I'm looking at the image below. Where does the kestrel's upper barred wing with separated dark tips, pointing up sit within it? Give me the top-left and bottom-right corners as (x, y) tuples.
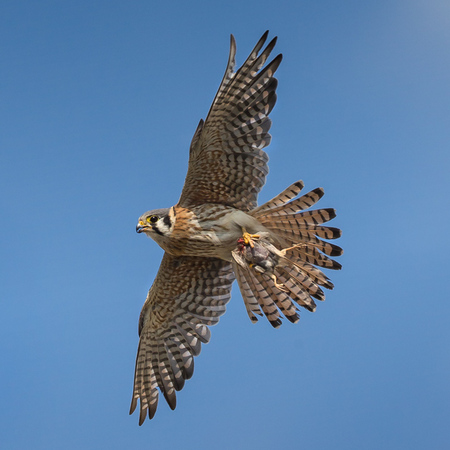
(178, 31), (282, 211)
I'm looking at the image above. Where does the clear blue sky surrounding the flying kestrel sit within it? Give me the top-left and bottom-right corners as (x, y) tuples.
(0, 0), (450, 450)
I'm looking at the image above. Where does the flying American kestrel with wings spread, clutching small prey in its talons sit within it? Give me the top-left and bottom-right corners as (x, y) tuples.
(130, 32), (342, 425)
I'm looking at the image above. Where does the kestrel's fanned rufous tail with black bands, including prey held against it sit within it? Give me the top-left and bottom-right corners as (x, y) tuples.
(233, 181), (342, 328)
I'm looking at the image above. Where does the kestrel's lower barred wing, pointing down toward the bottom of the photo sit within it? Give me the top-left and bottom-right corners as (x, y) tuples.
(130, 253), (234, 425)
